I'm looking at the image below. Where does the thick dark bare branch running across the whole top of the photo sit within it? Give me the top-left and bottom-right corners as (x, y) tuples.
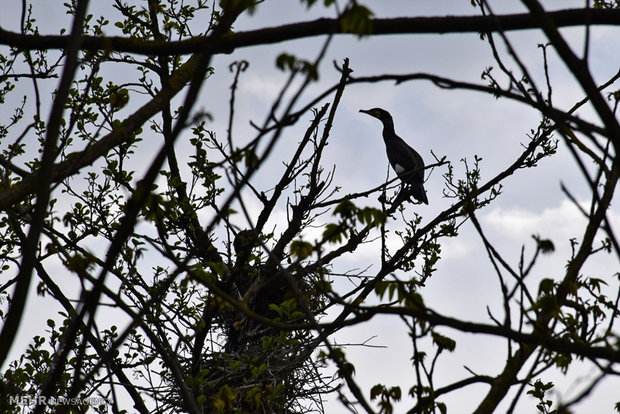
(0, 8), (620, 55)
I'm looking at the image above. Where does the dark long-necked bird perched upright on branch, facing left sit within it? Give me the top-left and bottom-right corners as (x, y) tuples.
(360, 108), (428, 204)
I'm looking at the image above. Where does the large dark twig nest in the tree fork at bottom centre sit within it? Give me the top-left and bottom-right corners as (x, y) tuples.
(159, 254), (333, 413)
